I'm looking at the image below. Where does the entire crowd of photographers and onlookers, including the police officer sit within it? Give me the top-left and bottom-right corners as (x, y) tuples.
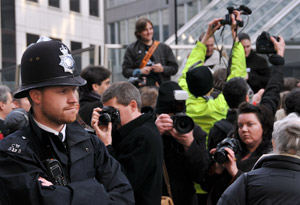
(0, 10), (300, 205)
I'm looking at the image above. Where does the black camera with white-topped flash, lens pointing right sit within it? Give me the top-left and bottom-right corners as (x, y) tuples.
(171, 90), (195, 134)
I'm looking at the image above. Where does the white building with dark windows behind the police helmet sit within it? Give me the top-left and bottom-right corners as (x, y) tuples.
(0, 0), (104, 89)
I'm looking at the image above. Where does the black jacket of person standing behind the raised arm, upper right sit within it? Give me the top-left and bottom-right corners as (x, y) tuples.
(246, 50), (271, 93)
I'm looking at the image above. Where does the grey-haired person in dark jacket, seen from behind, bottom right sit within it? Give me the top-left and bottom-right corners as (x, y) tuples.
(218, 113), (300, 205)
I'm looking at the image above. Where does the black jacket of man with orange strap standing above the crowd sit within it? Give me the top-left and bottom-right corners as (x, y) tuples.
(122, 40), (178, 83)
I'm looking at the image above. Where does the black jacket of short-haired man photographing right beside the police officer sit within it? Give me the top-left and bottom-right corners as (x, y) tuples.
(109, 113), (163, 205)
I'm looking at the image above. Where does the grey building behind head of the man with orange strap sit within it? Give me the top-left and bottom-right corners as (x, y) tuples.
(105, 0), (211, 45)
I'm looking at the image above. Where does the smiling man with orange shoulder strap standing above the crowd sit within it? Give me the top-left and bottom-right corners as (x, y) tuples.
(122, 17), (178, 86)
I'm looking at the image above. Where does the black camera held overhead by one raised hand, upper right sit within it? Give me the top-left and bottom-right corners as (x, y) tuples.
(256, 31), (279, 54)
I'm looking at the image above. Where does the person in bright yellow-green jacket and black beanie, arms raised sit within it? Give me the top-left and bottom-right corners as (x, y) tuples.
(178, 11), (247, 133)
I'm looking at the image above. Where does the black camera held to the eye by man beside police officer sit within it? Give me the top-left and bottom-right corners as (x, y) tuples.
(99, 106), (121, 125)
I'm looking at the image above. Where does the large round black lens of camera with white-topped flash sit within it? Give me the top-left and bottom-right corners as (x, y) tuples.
(173, 115), (194, 134)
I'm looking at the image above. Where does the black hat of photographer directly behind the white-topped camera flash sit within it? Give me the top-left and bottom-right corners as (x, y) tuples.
(155, 81), (182, 114)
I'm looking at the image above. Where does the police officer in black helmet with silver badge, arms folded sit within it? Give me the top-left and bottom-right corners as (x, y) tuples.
(0, 38), (134, 204)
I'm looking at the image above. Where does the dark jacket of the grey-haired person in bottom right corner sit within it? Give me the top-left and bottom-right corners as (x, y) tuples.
(218, 155), (300, 205)
